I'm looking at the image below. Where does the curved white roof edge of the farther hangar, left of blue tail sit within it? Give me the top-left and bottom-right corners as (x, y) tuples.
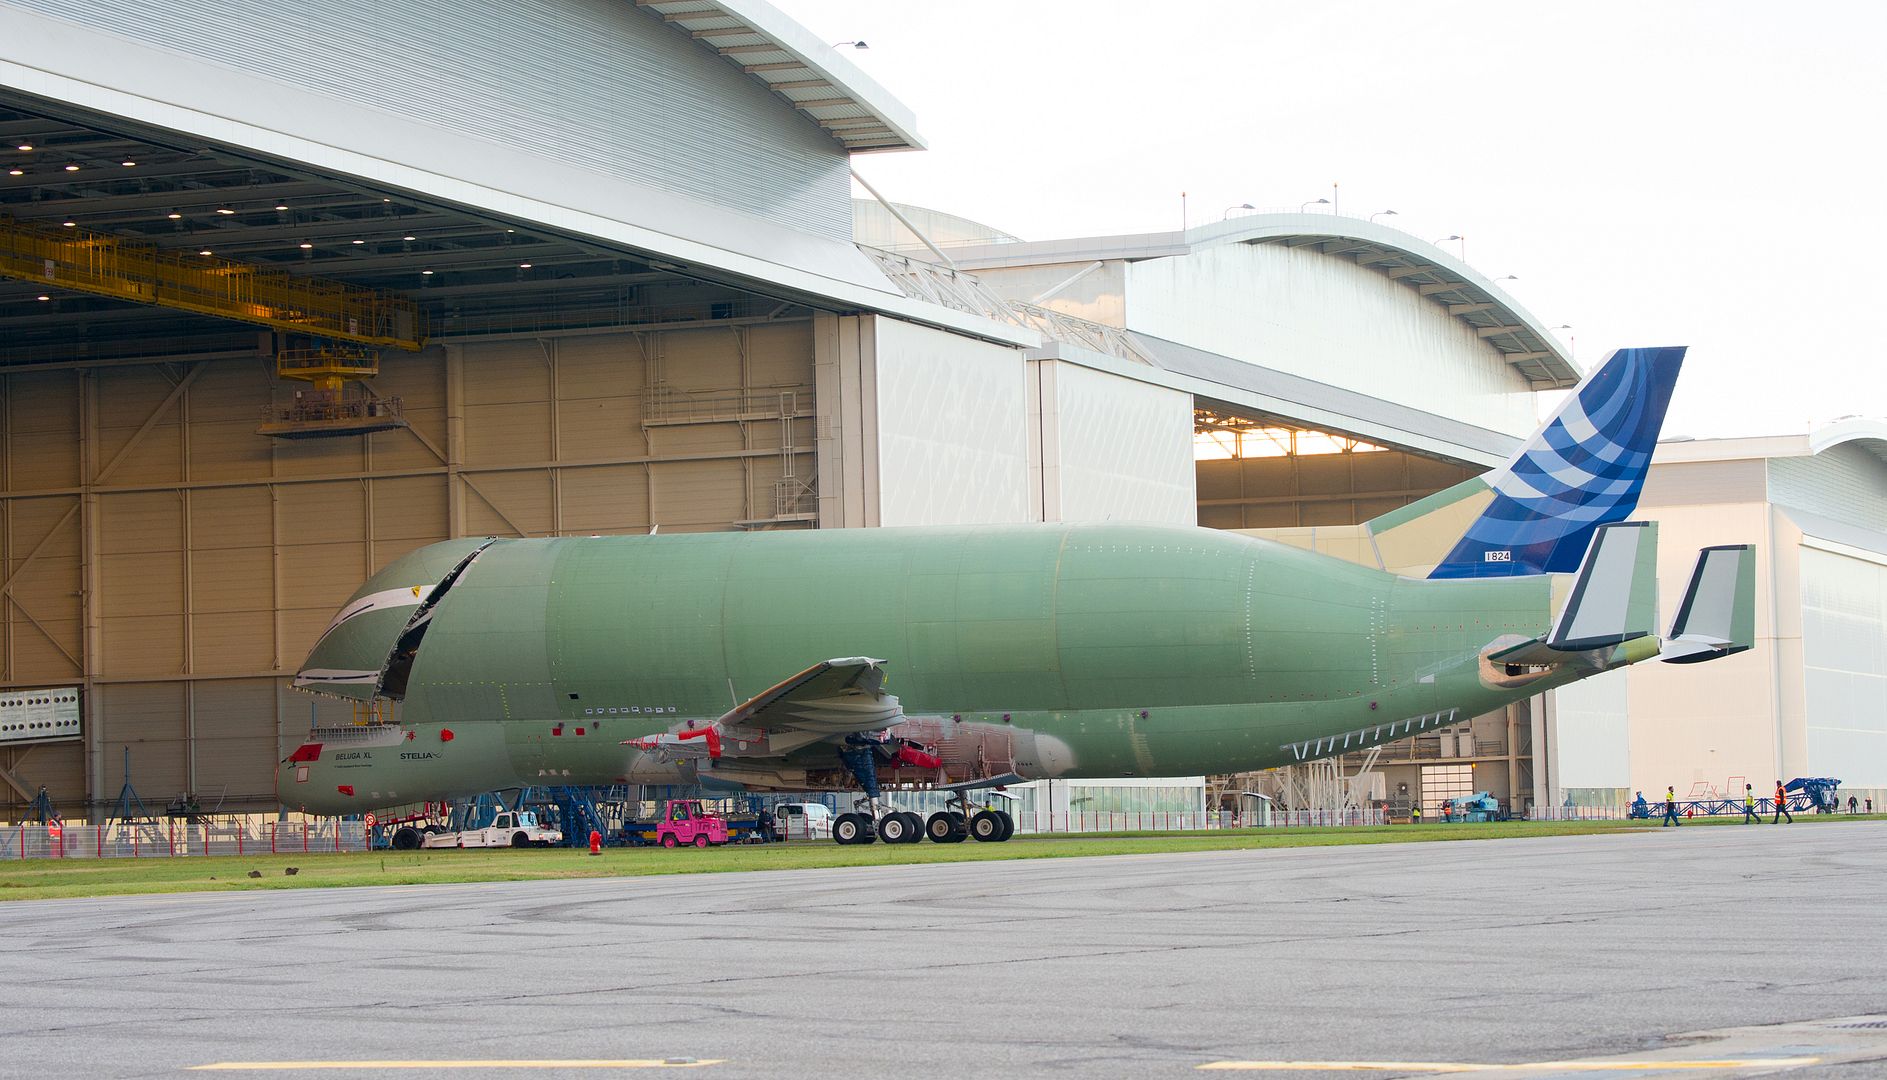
(951, 213), (1579, 389)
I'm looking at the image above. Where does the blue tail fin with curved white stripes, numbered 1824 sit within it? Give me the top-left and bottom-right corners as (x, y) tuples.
(1430, 346), (1683, 578)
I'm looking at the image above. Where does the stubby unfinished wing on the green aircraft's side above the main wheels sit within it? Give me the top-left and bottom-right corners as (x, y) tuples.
(626, 657), (904, 759)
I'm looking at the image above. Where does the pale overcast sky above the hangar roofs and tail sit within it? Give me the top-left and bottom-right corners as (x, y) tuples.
(774, 0), (1887, 436)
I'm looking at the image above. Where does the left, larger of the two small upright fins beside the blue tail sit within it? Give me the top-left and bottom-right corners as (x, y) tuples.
(1545, 521), (1657, 653)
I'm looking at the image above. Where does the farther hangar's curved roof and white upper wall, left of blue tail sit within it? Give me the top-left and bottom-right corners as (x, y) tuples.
(951, 213), (1579, 464)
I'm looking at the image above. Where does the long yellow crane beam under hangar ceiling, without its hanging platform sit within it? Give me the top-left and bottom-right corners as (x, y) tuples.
(0, 215), (426, 351)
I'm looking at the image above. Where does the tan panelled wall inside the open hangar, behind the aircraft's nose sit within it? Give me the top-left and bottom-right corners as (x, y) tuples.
(0, 321), (813, 819)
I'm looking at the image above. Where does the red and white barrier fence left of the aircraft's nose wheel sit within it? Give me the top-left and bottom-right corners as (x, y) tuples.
(0, 819), (366, 861)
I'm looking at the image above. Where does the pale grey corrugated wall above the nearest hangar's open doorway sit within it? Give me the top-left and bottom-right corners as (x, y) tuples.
(6, 0), (851, 240)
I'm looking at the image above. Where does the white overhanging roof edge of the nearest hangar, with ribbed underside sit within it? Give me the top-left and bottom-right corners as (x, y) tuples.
(636, 0), (925, 151)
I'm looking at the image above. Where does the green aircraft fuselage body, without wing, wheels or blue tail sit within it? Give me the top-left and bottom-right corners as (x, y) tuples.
(277, 525), (1622, 812)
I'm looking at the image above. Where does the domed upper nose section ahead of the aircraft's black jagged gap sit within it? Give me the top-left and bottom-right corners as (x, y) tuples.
(294, 536), (491, 700)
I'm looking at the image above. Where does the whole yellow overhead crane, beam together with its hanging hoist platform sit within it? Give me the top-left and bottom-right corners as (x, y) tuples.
(0, 215), (426, 438)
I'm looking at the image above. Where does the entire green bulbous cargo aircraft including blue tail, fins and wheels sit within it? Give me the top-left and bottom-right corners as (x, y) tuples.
(277, 347), (1755, 842)
